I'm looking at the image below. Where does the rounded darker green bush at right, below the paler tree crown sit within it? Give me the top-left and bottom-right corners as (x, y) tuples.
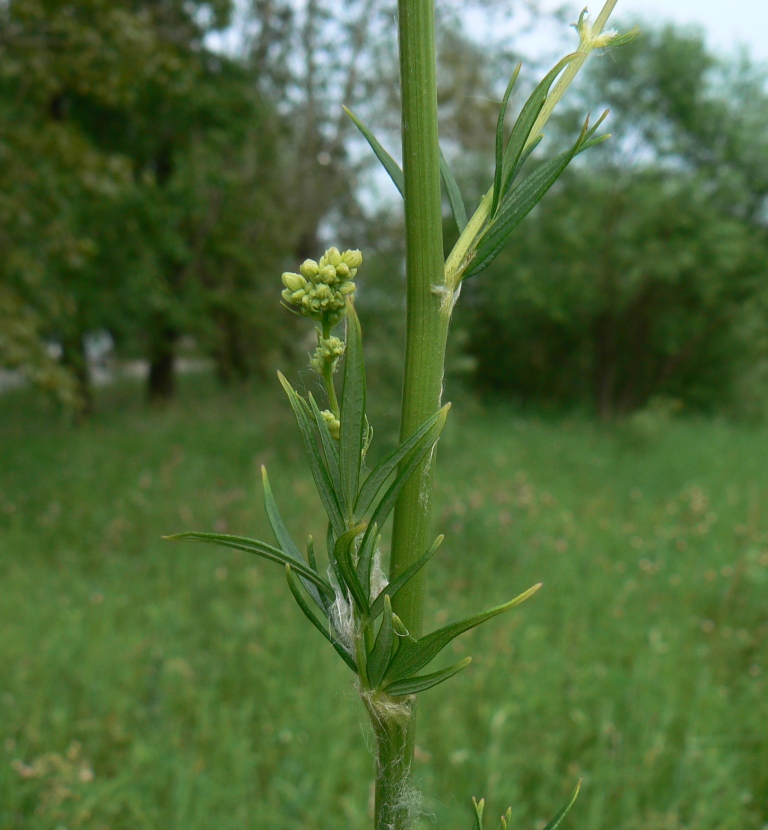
(468, 169), (768, 417)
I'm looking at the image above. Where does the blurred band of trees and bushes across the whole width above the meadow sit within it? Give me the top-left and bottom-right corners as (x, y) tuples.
(0, 8), (768, 417)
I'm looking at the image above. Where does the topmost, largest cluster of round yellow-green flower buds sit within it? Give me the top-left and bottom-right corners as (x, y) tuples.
(282, 248), (363, 326)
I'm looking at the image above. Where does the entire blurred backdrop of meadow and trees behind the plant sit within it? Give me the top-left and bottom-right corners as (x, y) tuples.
(0, 0), (768, 830)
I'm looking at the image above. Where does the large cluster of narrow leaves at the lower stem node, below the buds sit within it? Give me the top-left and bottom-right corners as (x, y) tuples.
(167, 301), (540, 698)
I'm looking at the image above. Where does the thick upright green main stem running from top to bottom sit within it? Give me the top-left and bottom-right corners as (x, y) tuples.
(373, 0), (450, 830)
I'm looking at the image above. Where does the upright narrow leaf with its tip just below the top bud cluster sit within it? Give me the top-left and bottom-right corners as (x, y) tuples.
(339, 300), (365, 520)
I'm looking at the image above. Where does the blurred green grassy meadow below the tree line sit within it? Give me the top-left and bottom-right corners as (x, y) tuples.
(0, 378), (768, 830)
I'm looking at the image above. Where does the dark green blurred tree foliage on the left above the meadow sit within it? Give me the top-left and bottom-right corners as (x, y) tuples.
(0, 0), (293, 407)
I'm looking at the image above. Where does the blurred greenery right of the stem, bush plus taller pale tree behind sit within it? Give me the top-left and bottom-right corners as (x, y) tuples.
(465, 28), (768, 417)
